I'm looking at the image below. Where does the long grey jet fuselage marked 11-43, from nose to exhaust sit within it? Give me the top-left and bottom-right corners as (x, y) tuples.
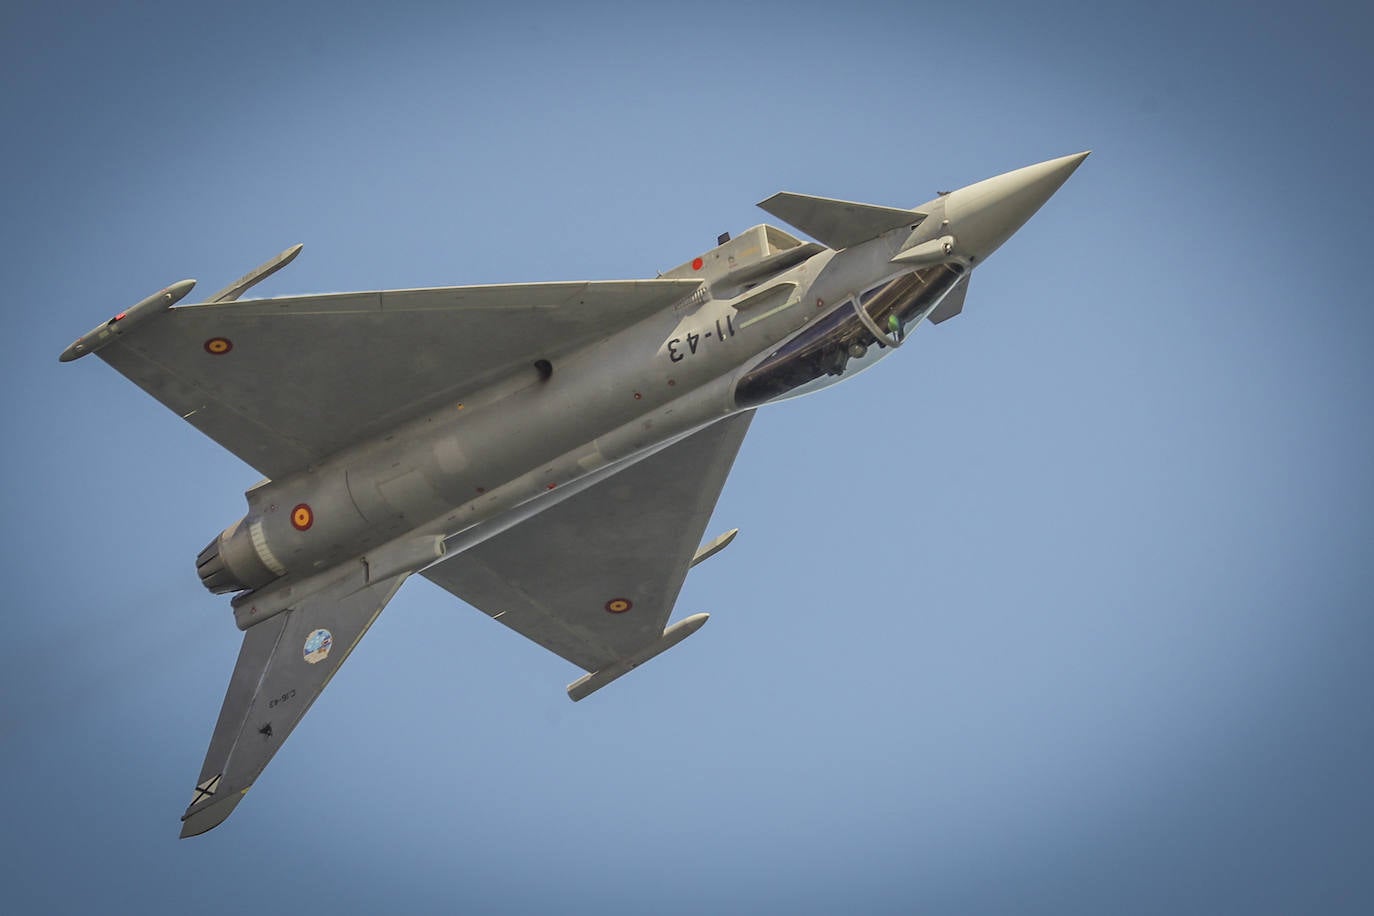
(198, 157), (1077, 628)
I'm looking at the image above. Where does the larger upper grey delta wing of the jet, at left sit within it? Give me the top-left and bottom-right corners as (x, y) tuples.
(96, 280), (701, 478)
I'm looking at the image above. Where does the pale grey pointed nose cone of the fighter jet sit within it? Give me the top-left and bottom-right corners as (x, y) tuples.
(945, 150), (1091, 262)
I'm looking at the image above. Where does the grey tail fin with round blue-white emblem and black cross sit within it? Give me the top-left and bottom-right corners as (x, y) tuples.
(181, 574), (407, 838)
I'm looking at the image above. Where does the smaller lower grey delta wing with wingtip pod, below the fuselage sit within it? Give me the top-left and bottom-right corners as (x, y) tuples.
(420, 411), (753, 699)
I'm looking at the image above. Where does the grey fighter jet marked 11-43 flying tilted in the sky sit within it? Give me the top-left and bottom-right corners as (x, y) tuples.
(60, 152), (1088, 836)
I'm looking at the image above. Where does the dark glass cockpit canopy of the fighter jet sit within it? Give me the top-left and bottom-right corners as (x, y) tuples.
(735, 264), (963, 408)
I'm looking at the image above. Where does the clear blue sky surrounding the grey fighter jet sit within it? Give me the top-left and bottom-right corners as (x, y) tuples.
(0, 1), (1374, 913)
